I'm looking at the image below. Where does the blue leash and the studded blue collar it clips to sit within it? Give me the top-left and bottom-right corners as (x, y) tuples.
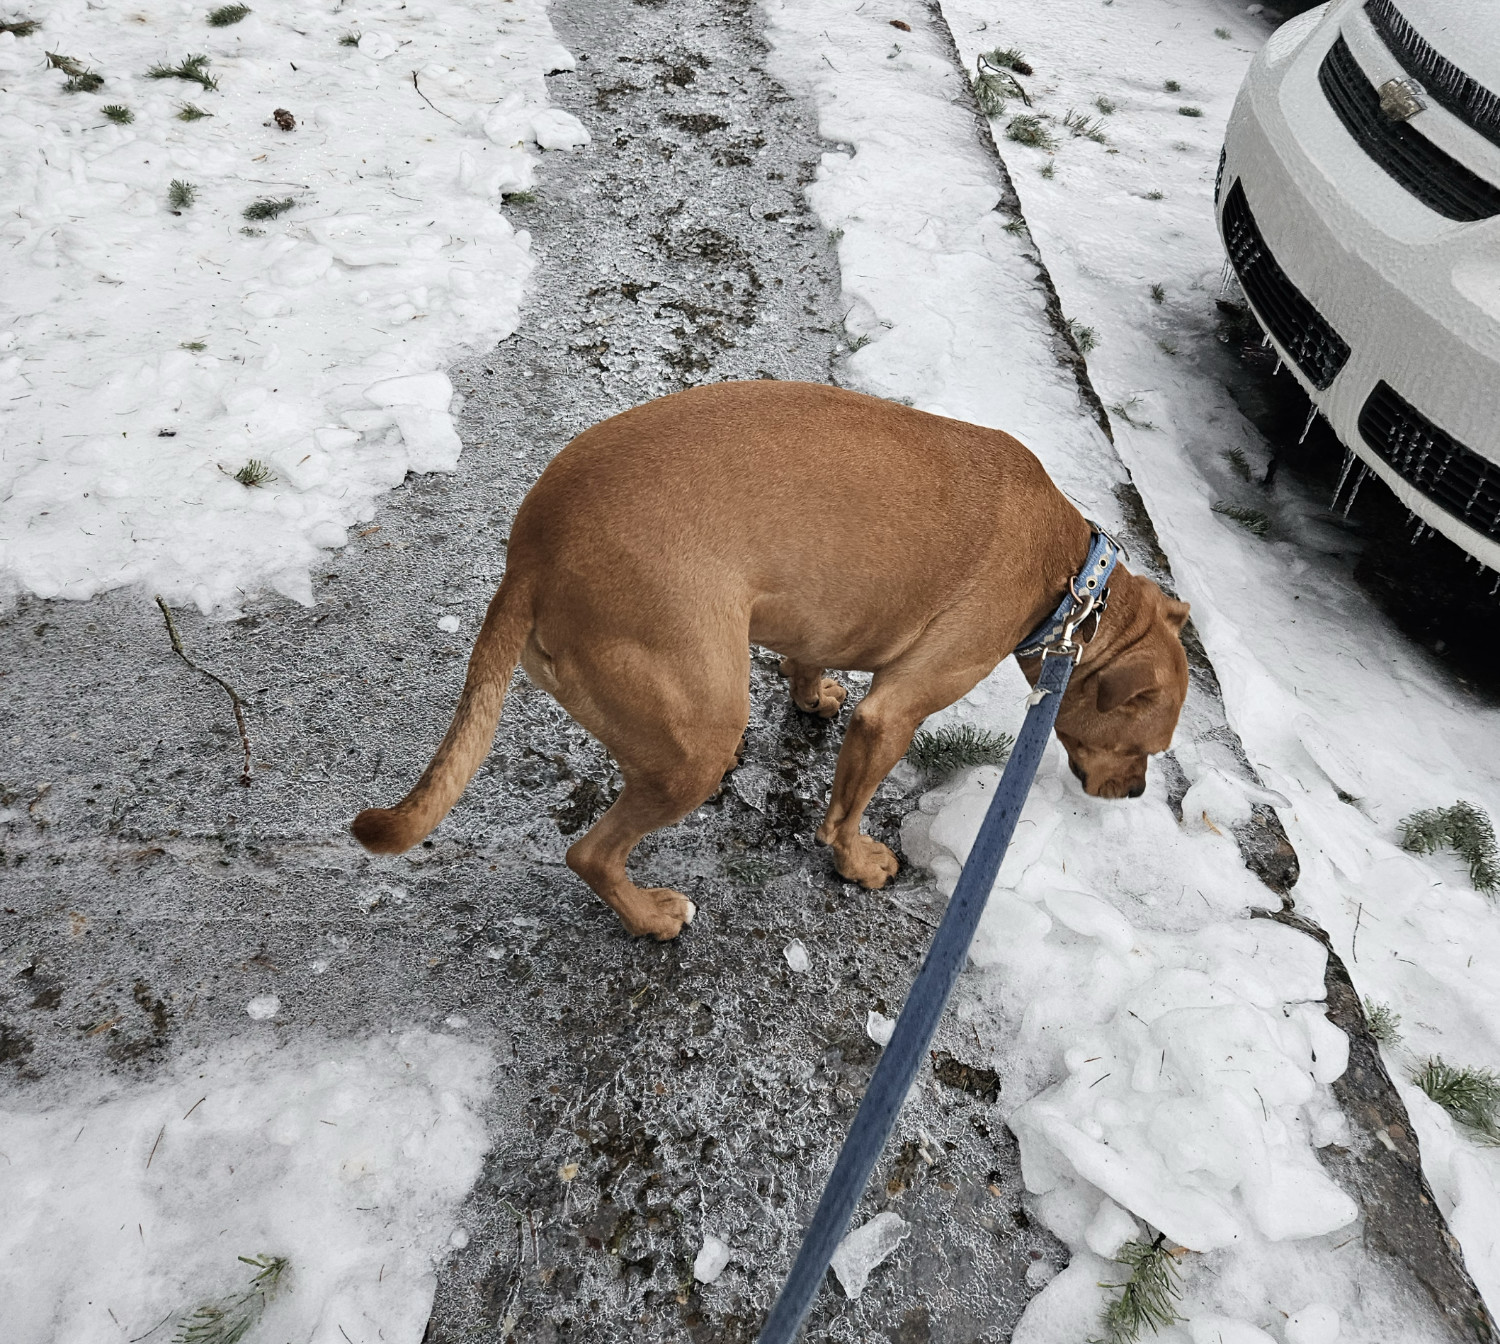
(758, 528), (1121, 1344)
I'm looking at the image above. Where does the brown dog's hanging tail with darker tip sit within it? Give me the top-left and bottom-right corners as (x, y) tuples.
(350, 575), (534, 854)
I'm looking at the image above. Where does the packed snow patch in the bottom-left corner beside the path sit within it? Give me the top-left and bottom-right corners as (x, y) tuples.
(0, 1032), (492, 1344)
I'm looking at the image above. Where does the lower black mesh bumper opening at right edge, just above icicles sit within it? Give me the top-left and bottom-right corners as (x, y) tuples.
(1359, 383), (1500, 539)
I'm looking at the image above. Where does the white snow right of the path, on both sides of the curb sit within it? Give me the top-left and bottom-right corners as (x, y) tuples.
(768, 0), (1500, 1344)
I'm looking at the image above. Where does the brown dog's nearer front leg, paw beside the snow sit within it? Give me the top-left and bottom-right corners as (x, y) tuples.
(818, 654), (990, 888)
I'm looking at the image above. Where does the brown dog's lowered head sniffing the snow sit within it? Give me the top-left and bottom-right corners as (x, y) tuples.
(1058, 572), (1188, 798)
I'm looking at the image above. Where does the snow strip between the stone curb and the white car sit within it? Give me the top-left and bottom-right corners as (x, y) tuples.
(944, 0), (1500, 1305)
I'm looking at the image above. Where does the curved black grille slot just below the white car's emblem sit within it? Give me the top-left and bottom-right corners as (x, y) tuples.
(1317, 38), (1500, 224)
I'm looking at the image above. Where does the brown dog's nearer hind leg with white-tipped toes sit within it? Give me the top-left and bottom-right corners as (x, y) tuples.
(558, 642), (750, 941)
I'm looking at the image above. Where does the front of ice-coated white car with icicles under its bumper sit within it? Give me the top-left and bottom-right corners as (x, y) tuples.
(1215, 0), (1500, 570)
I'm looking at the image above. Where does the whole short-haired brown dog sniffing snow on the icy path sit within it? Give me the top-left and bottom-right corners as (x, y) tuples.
(354, 381), (1188, 939)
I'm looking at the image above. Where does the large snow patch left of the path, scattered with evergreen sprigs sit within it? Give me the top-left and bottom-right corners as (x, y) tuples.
(0, 0), (588, 611)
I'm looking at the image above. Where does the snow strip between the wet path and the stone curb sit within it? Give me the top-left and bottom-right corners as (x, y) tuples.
(770, 3), (1470, 1344)
